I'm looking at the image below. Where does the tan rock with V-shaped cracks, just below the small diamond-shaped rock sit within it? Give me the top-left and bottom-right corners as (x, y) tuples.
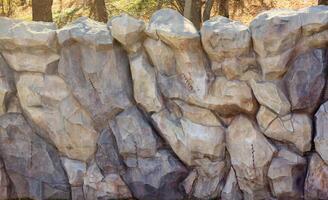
(256, 106), (313, 153)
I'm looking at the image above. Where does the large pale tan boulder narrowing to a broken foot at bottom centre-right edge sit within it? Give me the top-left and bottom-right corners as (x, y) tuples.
(152, 101), (229, 199)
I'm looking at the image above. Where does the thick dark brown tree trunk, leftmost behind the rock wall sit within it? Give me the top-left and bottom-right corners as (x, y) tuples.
(32, 0), (52, 22)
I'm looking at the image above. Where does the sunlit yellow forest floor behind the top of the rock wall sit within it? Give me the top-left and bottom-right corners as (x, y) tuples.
(12, 0), (317, 26)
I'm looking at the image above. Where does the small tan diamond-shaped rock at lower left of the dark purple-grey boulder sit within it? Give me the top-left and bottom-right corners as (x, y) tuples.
(250, 80), (290, 116)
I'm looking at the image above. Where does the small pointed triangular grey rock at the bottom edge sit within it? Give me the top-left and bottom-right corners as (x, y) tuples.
(221, 167), (243, 200)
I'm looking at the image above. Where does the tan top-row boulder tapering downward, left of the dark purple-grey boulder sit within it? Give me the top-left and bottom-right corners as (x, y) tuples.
(250, 9), (301, 79)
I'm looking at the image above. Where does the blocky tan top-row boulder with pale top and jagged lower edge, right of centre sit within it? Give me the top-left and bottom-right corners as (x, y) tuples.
(200, 16), (256, 79)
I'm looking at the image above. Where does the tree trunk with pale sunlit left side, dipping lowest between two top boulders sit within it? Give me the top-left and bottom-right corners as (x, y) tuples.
(183, 0), (202, 30)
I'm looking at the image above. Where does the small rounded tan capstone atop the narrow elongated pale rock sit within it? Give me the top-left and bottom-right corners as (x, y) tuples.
(110, 14), (146, 52)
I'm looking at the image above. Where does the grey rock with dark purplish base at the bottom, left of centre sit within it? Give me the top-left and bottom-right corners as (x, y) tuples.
(110, 107), (188, 199)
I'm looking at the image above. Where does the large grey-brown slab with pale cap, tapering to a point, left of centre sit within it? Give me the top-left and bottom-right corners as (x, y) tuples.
(57, 17), (132, 130)
